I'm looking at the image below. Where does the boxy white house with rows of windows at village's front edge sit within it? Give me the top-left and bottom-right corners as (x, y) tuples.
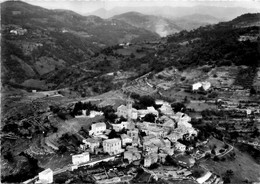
(103, 138), (123, 155)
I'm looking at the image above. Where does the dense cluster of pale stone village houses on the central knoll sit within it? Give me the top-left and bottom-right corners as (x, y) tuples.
(72, 101), (197, 170)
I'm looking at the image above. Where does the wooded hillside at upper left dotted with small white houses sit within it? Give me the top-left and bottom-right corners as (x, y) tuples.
(1, 1), (159, 84)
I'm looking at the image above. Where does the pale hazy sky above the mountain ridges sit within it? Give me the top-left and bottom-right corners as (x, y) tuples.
(20, 0), (260, 14)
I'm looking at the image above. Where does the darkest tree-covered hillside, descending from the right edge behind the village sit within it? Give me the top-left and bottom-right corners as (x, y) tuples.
(102, 14), (260, 83)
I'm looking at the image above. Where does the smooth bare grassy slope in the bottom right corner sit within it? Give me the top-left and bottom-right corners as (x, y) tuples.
(201, 149), (260, 184)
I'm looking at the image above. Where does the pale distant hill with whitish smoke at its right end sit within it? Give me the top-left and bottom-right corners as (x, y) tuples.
(111, 12), (182, 36)
